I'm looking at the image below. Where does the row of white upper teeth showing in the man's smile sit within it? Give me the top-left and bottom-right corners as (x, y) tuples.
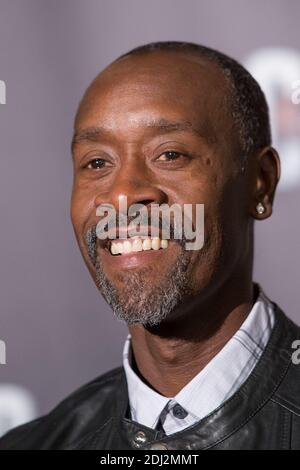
(107, 237), (169, 256)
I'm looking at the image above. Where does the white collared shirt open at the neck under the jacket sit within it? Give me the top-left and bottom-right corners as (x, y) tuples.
(123, 286), (274, 435)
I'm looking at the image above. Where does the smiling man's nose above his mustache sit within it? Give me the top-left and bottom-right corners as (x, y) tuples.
(95, 162), (167, 214)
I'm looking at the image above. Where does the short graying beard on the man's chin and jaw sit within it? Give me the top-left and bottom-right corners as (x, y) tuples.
(85, 228), (190, 326)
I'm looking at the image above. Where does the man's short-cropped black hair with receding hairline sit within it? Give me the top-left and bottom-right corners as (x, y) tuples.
(116, 41), (272, 165)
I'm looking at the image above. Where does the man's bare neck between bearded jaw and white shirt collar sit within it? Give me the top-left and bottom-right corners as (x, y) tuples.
(129, 282), (257, 398)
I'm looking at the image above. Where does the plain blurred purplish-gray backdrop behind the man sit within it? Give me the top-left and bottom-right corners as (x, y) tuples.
(0, 0), (300, 432)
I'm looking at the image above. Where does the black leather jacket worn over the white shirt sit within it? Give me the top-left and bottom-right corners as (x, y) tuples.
(0, 304), (300, 450)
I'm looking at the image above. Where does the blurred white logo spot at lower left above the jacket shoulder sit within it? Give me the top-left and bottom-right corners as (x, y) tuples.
(0, 384), (38, 436)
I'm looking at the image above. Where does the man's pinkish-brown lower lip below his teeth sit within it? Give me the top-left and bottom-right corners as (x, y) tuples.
(99, 242), (178, 269)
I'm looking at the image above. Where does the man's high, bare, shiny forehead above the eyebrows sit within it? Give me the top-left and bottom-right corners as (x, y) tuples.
(75, 52), (228, 137)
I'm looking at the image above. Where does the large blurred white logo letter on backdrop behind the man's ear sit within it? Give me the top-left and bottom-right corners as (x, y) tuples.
(244, 48), (300, 191)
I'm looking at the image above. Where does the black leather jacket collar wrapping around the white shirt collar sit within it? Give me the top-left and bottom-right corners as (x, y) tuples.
(71, 303), (299, 450)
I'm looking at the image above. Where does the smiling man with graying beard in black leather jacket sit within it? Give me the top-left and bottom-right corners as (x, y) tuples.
(0, 42), (300, 450)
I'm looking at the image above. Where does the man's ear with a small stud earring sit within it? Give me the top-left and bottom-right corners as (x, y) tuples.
(251, 147), (280, 220)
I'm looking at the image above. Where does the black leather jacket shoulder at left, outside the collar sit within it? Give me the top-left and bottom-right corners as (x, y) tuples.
(0, 367), (127, 450)
